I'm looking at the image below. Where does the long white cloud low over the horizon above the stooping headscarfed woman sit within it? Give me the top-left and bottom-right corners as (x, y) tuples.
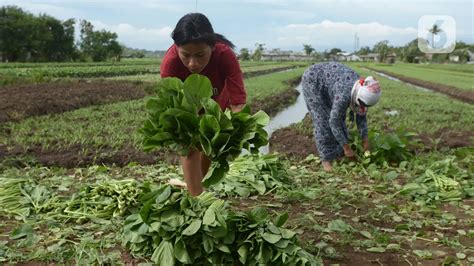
(274, 20), (417, 49)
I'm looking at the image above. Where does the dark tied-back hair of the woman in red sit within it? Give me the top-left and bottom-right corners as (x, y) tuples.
(171, 13), (235, 49)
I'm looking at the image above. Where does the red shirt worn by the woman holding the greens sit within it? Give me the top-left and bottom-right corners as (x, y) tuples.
(160, 42), (247, 110)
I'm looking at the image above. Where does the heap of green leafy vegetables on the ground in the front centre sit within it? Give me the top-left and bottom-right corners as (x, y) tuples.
(122, 185), (318, 265)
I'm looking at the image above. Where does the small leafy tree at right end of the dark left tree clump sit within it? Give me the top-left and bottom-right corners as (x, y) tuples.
(80, 20), (123, 62)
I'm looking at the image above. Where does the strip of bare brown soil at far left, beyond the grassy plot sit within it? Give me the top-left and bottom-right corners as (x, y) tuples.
(0, 80), (145, 123)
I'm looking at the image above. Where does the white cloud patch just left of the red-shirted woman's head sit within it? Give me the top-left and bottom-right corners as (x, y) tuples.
(91, 20), (173, 50)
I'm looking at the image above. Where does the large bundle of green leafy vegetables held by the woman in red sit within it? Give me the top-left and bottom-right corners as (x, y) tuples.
(140, 74), (269, 187)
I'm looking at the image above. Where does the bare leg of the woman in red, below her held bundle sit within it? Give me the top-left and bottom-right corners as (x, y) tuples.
(180, 150), (203, 196)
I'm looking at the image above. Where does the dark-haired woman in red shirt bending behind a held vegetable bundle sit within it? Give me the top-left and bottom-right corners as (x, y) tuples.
(160, 13), (246, 196)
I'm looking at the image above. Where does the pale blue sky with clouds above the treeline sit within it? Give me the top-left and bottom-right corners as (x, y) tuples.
(0, 0), (474, 52)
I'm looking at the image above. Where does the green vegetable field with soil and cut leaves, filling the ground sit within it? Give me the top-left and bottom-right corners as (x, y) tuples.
(0, 59), (474, 265)
